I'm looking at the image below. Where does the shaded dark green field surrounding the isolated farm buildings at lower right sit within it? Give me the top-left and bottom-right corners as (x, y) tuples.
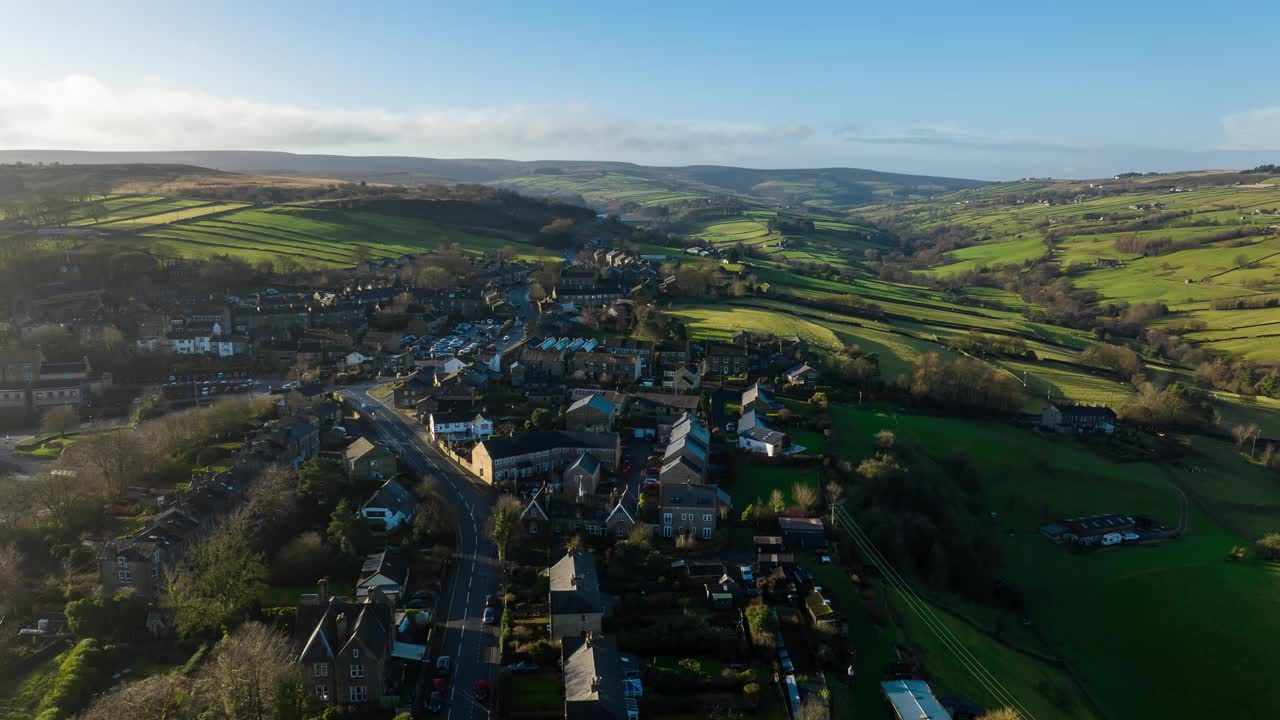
(833, 407), (1280, 717)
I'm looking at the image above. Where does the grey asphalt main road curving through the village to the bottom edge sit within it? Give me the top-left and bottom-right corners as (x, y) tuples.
(339, 386), (502, 720)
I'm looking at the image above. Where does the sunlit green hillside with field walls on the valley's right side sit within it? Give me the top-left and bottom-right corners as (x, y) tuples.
(863, 173), (1280, 363)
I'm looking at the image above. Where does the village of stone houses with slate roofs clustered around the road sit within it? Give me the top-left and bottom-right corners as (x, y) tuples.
(0, 234), (1137, 720)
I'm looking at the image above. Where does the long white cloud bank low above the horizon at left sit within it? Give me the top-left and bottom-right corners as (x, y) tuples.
(0, 76), (814, 158)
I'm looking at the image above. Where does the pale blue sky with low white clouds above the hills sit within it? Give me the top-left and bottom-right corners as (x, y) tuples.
(0, 0), (1280, 179)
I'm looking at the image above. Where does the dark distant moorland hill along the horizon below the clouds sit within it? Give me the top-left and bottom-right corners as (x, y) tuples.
(0, 150), (986, 210)
